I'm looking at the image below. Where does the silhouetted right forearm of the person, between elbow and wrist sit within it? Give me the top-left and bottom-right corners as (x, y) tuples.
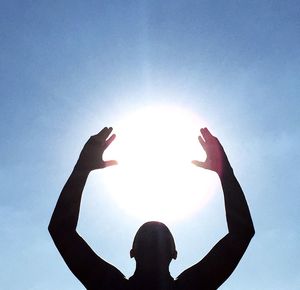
(219, 163), (254, 239)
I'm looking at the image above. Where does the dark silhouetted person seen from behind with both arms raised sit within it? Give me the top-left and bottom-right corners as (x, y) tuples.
(49, 128), (254, 290)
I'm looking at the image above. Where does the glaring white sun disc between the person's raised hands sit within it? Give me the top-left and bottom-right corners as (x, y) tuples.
(104, 106), (215, 222)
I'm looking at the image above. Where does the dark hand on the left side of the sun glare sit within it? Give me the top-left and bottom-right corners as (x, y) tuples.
(75, 127), (117, 172)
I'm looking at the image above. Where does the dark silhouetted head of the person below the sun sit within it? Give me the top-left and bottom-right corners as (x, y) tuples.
(130, 221), (177, 266)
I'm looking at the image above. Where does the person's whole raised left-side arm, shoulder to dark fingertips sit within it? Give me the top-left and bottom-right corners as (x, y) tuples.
(48, 128), (123, 289)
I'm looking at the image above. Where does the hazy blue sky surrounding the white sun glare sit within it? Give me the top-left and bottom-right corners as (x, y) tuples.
(0, 0), (300, 290)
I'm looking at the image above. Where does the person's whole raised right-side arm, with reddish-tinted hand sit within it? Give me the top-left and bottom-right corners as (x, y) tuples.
(178, 128), (254, 289)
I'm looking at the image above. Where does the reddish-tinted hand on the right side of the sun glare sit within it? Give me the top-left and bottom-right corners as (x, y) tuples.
(192, 128), (230, 175)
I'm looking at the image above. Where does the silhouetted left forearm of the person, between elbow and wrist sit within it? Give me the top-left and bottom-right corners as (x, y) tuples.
(49, 166), (89, 235)
